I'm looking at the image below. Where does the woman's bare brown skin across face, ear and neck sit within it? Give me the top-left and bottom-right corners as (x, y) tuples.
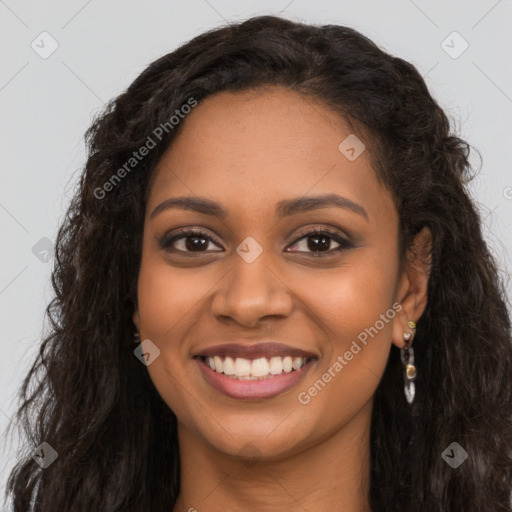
(133, 87), (430, 512)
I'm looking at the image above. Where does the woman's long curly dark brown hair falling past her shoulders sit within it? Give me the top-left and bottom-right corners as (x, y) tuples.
(6, 16), (512, 512)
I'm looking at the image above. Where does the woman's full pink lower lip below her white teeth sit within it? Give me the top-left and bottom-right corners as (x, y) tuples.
(195, 357), (316, 400)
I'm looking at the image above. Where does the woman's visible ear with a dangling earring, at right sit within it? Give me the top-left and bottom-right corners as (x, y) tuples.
(392, 227), (432, 348)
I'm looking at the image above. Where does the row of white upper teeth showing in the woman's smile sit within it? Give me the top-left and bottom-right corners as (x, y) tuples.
(206, 356), (308, 380)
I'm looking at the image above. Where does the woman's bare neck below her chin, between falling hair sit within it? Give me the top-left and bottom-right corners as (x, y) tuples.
(173, 401), (373, 512)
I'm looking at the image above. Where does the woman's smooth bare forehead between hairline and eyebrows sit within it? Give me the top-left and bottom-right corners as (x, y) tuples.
(148, 87), (393, 224)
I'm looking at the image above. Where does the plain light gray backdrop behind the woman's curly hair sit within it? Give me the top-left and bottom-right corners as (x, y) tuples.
(0, 0), (512, 504)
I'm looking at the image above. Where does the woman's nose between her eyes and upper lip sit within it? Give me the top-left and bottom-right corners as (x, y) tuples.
(211, 249), (293, 327)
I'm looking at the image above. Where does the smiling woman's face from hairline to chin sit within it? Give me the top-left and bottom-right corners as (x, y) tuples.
(134, 88), (417, 458)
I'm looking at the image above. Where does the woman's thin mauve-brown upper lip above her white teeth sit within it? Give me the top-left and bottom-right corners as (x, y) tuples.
(194, 342), (316, 359)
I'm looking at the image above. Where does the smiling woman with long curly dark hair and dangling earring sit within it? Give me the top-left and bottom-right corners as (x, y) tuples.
(5, 16), (512, 512)
